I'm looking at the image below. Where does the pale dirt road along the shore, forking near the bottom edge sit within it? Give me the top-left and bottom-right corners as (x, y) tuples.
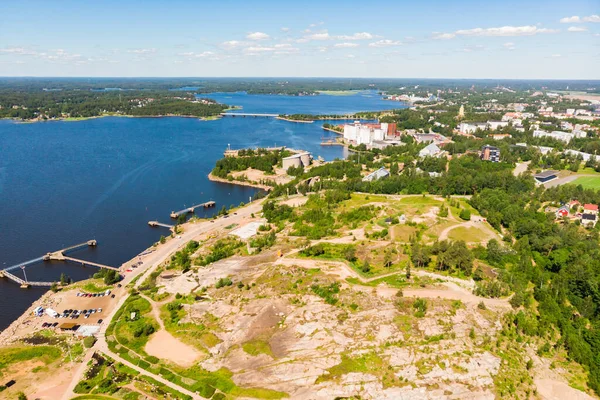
(62, 200), (263, 400)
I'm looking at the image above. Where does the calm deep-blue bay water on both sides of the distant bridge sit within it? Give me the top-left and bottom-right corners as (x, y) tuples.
(0, 93), (404, 329)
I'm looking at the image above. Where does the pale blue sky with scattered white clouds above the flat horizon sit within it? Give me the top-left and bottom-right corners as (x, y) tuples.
(0, 0), (600, 79)
